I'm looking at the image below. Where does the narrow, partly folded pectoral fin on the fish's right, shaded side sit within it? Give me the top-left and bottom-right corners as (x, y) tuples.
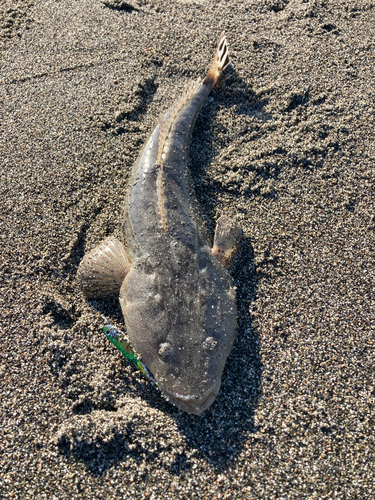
(211, 215), (242, 267)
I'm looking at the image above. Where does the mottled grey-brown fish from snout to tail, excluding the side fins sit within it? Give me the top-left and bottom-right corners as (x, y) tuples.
(120, 36), (236, 415)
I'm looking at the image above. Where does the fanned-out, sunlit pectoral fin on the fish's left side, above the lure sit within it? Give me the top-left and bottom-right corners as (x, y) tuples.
(77, 236), (131, 298)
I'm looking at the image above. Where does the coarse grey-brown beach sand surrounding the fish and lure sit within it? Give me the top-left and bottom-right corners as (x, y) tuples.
(0, 0), (375, 500)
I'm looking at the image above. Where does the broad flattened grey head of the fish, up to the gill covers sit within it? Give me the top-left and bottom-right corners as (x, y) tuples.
(120, 247), (237, 415)
